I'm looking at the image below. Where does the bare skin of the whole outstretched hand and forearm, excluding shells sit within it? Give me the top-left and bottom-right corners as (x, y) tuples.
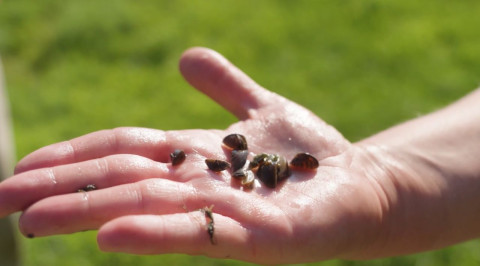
(0, 48), (480, 264)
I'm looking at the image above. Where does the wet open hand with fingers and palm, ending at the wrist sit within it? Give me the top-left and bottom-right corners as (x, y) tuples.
(0, 48), (383, 263)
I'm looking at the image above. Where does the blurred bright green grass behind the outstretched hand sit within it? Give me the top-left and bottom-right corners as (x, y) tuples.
(0, 0), (480, 266)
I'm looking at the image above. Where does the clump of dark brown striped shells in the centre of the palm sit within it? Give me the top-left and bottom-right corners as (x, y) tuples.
(205, 134), (319, 189)
